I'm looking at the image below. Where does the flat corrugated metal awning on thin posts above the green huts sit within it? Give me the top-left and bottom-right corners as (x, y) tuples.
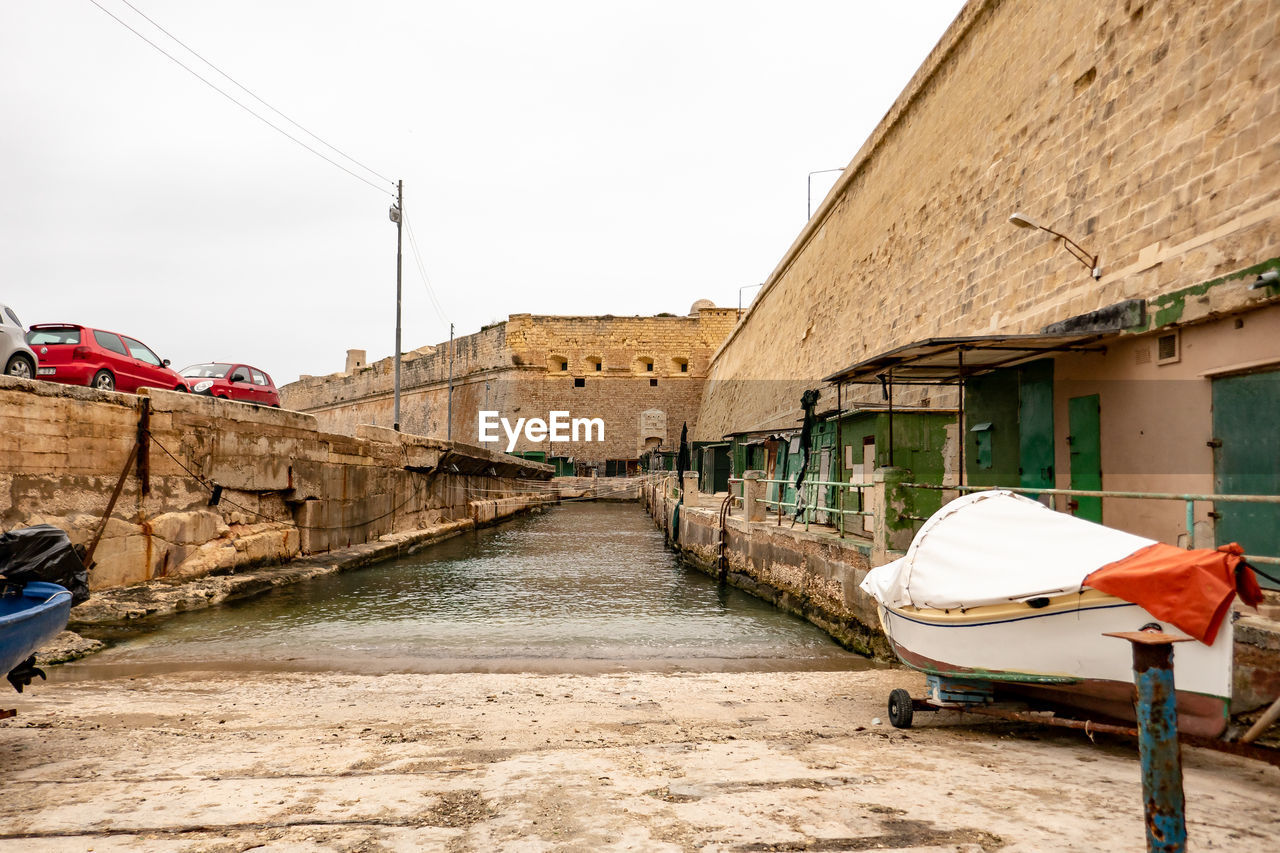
(823, 332), (1115, 384)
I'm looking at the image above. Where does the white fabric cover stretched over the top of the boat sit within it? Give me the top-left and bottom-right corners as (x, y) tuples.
(861, 489), (1155, 610)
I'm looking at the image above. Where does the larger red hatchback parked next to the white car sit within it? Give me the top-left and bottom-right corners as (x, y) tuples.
(27, 323), (188, 393)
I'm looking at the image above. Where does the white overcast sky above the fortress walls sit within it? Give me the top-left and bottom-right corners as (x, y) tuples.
(0, 0), (963, 384)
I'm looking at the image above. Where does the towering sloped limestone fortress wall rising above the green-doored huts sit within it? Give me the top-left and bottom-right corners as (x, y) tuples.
(696, 0), (1280, 441)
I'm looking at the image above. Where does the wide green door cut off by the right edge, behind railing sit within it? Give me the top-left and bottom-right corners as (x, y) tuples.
(1213, 370), (1280, 588)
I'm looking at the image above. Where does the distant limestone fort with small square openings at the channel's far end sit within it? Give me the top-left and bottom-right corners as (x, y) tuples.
(280, 300), (737, 475)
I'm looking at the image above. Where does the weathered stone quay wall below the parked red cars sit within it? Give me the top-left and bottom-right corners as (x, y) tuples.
(0, 377), (552, 589)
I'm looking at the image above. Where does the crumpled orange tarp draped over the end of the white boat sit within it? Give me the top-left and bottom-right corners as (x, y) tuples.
(1084, 542), (1262, 646)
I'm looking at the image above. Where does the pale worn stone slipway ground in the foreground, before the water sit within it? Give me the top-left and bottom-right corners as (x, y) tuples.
(0, 670), (1280, 852)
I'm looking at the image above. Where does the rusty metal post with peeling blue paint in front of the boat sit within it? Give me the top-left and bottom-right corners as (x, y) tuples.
(1107, 630), (1189, 853)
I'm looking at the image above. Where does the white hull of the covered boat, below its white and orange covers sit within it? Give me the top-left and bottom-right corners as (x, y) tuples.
(879, 590), (1233, 736)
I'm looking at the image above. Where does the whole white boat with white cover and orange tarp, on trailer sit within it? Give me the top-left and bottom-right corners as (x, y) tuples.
(861, 491), (1261, 736)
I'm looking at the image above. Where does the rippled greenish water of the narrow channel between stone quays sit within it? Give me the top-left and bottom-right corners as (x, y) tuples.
(58, 502), (869, 680)
